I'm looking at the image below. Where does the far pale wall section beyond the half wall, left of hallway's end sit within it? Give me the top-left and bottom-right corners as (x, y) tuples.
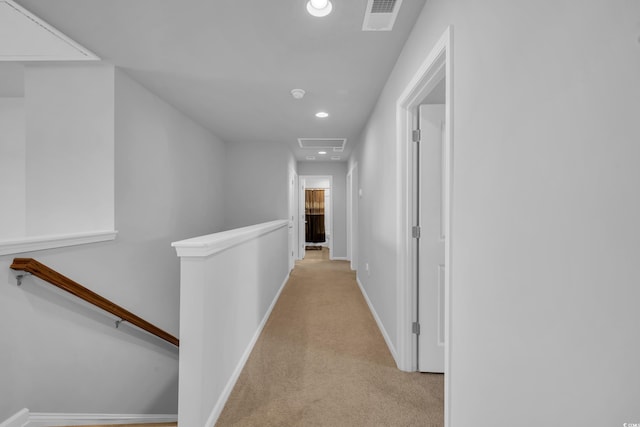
(224, 143), (296, 230)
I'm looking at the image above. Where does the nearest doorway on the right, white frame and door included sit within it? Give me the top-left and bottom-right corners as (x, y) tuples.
(396, 27), (453, 425)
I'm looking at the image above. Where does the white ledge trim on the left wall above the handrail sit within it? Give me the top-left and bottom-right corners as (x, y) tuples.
(0, 230), (118, 255)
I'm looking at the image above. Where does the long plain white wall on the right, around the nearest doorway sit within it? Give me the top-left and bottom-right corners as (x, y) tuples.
(353, 0), (640, 426)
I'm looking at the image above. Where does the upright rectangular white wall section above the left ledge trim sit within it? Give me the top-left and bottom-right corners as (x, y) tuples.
(25, 64), (114, 236)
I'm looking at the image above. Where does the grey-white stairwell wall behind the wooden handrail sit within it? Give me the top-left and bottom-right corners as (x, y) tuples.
(0, 71), (224, 419)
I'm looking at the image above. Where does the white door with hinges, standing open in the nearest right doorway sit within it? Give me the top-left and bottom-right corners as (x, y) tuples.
(418, 104), (446, 373)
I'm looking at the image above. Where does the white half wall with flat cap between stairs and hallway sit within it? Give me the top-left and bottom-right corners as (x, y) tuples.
(173, 219), (289, 427)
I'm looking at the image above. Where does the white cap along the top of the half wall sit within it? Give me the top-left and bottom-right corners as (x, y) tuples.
(171, 219), (289, 258)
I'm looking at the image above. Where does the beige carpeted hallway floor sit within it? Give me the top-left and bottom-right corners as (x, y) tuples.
(216, 249), (444, 427)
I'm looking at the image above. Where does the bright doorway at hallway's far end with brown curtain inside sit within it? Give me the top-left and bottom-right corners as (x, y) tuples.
(299, 175), (333, 259)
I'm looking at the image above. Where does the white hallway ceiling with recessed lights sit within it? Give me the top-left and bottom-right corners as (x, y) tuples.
(10, 0), (425, 160)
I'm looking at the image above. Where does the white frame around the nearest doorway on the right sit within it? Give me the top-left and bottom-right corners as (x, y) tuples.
(396, 26), (453, 425)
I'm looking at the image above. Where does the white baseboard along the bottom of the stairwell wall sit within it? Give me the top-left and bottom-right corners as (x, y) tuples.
(25, 413), (178, 427)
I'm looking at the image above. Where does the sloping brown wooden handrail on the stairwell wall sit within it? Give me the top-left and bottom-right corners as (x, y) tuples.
(11, 258), (180, 347)
